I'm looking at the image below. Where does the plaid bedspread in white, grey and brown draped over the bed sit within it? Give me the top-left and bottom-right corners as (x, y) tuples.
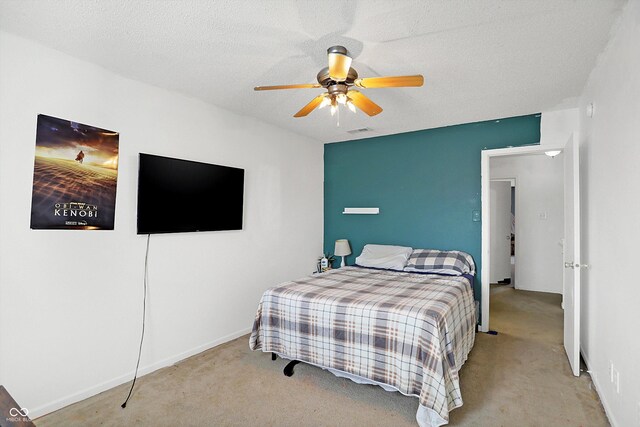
(249, 267), (475, 420)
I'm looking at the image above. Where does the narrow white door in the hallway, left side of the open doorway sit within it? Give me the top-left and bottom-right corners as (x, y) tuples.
(489, 181), (511, 283)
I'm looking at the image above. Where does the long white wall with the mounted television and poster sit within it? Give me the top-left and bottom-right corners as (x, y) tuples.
(0, 33), (323, 416)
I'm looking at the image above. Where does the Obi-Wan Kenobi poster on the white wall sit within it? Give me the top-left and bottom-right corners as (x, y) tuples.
(31, 114), (119, 230)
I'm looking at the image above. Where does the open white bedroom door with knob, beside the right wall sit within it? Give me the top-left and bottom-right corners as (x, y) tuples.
(563, 133), (581, 376)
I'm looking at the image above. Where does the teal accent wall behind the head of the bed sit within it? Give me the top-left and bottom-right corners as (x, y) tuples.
(324, 114), (540, 300)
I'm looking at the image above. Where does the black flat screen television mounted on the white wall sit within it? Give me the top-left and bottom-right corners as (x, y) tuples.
(138, 153), (244, 234)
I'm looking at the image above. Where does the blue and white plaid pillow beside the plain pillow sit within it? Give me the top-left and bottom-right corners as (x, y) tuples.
(404, 249), (476, 276)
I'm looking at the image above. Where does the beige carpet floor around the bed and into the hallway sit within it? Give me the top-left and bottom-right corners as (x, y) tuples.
(36, 286), (608, 427)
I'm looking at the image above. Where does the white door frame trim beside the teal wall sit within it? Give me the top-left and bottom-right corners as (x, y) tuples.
(478, 145), (564, 332)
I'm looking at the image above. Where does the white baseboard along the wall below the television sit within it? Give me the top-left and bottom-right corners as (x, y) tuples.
(29, 328), (251, 419)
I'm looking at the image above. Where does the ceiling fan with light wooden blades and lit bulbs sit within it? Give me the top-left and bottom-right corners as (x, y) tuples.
(254, 46), (424, 117)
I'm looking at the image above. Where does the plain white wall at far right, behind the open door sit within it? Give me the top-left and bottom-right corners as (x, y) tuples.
(580, 0), (640, 427)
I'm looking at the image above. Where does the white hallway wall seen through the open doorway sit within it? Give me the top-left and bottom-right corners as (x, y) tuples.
(490, 154), (564, 294)
